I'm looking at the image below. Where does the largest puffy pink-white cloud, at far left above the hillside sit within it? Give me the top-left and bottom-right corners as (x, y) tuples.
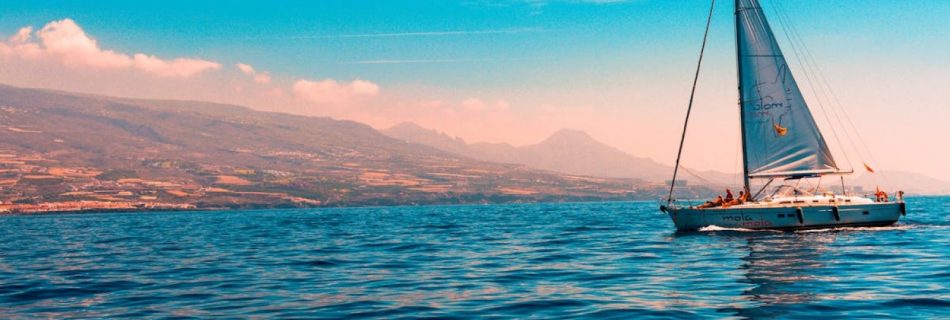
(0, 18), (221, 77)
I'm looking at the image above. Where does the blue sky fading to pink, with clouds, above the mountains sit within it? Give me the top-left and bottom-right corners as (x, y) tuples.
(0, 0), (950, 180)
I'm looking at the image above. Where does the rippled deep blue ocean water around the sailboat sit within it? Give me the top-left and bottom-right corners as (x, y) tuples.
(0, 198), (950, 319)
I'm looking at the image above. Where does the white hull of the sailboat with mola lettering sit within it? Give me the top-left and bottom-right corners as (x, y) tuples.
(666, 202), (905, 230)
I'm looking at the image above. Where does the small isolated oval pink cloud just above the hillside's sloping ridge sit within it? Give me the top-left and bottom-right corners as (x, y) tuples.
(293, 79), (379, 104)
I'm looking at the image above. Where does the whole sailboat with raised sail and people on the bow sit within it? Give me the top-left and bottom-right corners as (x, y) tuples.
(660, 0), (906, 230)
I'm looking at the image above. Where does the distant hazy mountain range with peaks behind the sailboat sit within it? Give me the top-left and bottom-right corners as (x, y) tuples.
(381, 122), (950, 194)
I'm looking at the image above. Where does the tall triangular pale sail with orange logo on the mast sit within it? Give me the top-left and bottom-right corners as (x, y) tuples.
(736, 0), (838, 177)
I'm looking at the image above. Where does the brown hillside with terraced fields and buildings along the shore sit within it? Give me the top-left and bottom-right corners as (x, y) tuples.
(0, 86), (712, 207)
